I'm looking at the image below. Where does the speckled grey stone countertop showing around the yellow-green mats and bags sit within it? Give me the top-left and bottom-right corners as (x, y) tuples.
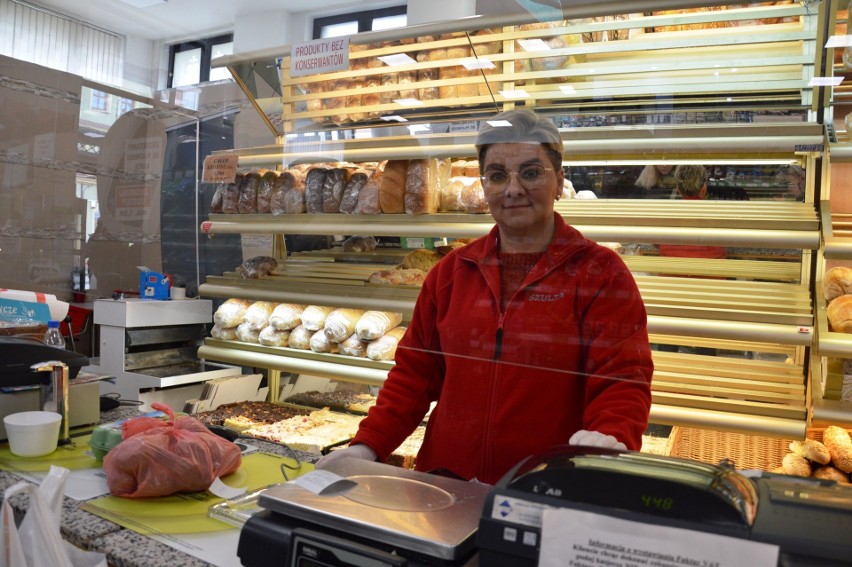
(0, 407), (317, 567)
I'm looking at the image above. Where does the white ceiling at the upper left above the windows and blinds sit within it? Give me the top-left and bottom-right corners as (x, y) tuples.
(30, 0), (380, 41)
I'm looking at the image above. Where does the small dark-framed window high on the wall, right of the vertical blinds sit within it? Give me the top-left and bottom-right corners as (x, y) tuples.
(168, 34), (234, 88)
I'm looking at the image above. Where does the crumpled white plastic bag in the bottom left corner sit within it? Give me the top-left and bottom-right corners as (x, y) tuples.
(0, 466), (107, 567)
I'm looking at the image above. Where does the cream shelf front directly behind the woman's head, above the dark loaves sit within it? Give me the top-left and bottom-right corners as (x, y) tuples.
(225, 123), (825, 168)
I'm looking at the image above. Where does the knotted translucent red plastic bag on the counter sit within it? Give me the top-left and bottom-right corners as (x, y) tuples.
(104, 403), (242, 498)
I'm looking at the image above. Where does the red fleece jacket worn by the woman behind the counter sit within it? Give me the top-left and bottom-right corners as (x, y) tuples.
(353, 214), (653, 484)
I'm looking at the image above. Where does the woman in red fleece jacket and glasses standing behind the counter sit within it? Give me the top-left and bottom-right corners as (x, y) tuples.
(317, 110), (653, 484)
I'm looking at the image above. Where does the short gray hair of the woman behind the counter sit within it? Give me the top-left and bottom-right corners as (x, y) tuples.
(475, 108), (564, 171)
